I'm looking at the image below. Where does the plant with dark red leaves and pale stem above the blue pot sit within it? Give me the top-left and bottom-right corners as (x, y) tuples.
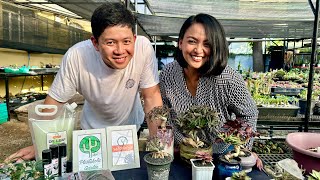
(218, 119), (259, 162)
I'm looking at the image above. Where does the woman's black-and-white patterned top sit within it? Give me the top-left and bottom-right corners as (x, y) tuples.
(160, 61), (258, 153)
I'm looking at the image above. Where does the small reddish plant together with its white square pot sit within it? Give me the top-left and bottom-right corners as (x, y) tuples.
(190, 151), (214, 180)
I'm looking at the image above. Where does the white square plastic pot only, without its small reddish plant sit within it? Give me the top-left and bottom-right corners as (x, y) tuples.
(190, 159), (214, 180)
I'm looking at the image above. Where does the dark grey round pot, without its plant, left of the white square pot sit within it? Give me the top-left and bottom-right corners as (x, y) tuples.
(143, 153), (173, 180)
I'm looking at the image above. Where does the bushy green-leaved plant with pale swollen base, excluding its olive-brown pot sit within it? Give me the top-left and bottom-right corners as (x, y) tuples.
(175, 106), (220, 148)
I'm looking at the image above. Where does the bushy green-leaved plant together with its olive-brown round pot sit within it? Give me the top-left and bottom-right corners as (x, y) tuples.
(174, 106), (220, 163)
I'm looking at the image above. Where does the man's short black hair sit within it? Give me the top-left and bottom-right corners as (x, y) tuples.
(91, 2), (135, 39)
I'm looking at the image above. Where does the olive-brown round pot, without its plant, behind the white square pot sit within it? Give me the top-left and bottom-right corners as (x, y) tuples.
(180, 142), (212, 164)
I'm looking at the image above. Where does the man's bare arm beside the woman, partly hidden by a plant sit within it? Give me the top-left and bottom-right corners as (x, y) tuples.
(141, 85), (162, 136)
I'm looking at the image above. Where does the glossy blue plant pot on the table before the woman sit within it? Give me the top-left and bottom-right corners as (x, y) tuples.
(217, 155), (242, 178)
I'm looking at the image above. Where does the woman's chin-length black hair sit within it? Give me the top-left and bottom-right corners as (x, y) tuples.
(175, 14), (229, 76)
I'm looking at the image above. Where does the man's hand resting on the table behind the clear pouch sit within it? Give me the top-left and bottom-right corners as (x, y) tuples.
(4, 146), (35, 163)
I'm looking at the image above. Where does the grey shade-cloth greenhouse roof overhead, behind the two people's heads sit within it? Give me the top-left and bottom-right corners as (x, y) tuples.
(11, 0), (315, 39)
